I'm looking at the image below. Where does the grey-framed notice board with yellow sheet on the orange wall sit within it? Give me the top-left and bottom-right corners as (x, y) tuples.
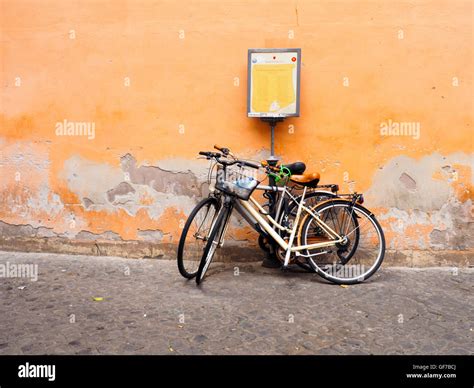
(247, 48), (301, 118)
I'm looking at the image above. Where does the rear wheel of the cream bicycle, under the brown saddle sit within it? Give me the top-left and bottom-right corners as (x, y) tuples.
(300, 199), (385, 284)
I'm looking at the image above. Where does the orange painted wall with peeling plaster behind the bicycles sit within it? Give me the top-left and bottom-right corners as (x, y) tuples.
(0, 0), (473, 253)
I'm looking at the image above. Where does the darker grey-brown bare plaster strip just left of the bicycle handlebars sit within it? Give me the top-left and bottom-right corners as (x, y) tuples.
(121, 154), (200, 197)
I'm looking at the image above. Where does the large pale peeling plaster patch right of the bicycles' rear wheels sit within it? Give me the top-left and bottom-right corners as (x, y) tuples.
(372, 153), (474, 250)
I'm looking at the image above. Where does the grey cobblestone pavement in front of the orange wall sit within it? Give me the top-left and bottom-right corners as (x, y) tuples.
(0, 252), (474, 354)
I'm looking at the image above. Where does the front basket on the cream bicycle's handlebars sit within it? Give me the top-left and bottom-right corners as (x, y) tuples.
(215, 166), (260, 201)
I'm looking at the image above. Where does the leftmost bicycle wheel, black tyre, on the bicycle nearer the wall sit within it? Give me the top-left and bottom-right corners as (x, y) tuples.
(178, 197), (219, 279)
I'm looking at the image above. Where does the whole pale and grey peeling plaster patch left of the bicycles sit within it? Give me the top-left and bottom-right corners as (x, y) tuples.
(61, 154), (200, 221)
